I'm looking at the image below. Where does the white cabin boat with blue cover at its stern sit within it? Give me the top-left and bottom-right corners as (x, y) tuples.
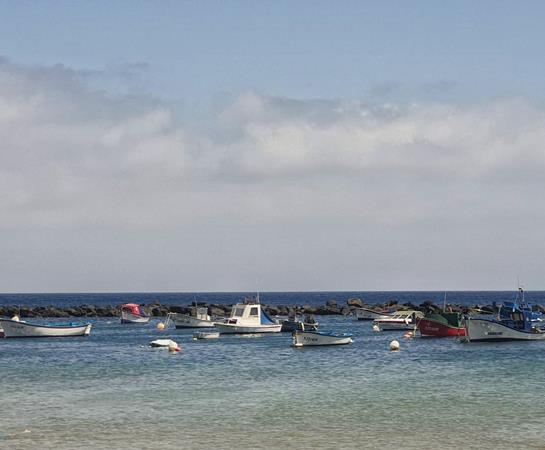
(215, 295), (282, 334)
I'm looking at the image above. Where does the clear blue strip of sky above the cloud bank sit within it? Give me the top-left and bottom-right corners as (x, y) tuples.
(0, 1), (545, 101)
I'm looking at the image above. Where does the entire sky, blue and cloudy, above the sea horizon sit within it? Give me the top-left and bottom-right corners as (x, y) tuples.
(0, 1), (545, 292)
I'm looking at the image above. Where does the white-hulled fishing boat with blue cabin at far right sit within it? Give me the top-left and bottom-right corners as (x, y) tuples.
(464, 288), (545, 342)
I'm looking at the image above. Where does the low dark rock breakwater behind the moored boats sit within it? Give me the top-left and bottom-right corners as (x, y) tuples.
(0, 298), (545, 318)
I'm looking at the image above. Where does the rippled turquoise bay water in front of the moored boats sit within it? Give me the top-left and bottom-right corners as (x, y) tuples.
(0, 316), (545, 449)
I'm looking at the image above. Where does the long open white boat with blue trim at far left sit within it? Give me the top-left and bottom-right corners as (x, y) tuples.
(0, 316), (91, 338)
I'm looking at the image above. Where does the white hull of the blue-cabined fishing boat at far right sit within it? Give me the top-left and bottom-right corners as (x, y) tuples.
(465, 319), (545, 342)
